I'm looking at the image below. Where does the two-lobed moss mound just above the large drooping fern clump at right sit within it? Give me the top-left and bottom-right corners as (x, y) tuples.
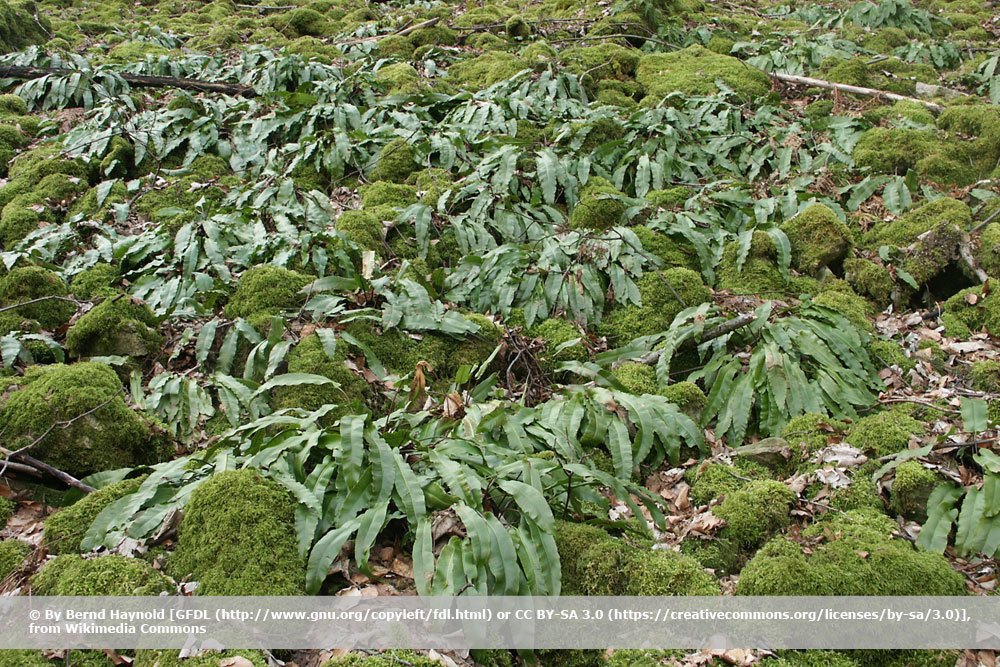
(600, 268), (712, 344)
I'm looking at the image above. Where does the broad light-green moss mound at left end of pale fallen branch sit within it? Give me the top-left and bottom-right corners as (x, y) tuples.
(635, 45), (771, 102)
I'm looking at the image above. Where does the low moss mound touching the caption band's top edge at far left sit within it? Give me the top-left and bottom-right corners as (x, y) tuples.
(31, 555), (175, 596)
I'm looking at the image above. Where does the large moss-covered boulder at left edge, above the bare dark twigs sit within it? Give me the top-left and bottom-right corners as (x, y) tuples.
(0, 362), (167, 476)
